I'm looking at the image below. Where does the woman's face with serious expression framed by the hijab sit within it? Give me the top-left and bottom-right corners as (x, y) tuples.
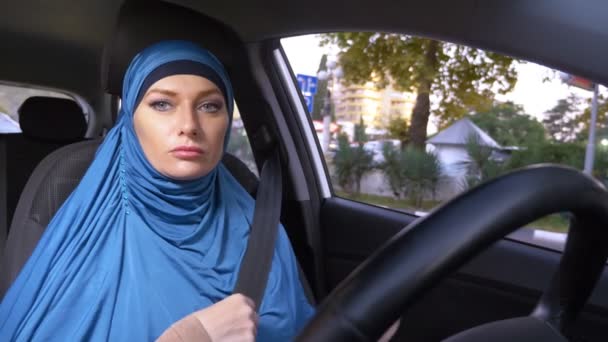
(133, 75), (228, 180)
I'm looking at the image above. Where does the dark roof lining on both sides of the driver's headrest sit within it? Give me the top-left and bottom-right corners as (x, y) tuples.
(0, 0), (608, 101)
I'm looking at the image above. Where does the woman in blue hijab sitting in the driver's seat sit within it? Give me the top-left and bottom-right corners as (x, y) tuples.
(0, 41), (312, 341)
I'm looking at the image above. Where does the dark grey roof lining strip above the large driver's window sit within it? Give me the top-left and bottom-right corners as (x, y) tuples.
(171, 0), (608, 83)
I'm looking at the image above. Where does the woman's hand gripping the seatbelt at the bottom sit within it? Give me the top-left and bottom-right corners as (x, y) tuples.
(194, 294), (258, 342)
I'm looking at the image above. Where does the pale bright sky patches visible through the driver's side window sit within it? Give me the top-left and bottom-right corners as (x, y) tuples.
(281, 35), (605, 131)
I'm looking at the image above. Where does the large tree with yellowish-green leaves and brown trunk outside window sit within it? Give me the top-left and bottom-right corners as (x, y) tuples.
(322, 32), (517, 149)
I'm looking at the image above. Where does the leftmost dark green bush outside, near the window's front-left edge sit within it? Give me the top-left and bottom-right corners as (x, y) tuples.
(334, 134), (374, 194)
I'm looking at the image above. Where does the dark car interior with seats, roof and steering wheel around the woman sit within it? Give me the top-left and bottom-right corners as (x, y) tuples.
(0, 0), (608, 341)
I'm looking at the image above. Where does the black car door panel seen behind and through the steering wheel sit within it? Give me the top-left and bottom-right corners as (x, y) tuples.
(321, 197), (608, 341)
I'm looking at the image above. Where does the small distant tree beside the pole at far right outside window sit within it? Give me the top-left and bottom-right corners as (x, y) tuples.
(543, 94), (589, 142)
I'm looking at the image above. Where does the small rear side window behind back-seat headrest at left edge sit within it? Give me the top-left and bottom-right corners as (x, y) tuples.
(0, 84), (80, 134)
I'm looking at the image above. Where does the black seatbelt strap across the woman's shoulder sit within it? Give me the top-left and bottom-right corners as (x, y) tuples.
(234, 148), (283, 309)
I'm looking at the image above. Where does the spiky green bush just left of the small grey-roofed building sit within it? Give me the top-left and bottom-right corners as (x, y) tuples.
(380, 144), (441, 208)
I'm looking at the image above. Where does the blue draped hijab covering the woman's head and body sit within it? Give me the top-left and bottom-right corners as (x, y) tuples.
(0, 41), (313, 341)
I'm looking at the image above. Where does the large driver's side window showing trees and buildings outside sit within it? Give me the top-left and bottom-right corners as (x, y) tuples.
(282, 32), (608, 240)
